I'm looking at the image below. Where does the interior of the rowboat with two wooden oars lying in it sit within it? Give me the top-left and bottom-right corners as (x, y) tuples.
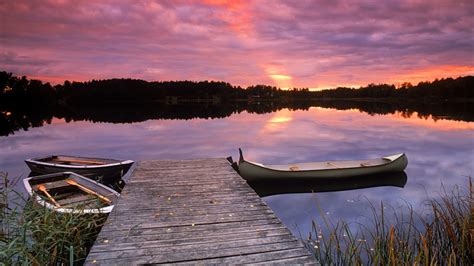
(30, 175), (116, 209)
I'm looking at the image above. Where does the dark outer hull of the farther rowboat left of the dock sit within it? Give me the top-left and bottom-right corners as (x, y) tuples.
(25, 159), (134, 182)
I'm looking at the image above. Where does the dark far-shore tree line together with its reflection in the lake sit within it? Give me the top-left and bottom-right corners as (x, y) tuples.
(0, 72), (474, 136)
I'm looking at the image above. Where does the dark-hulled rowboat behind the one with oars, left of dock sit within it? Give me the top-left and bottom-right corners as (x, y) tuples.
(25, 155), (134, 182)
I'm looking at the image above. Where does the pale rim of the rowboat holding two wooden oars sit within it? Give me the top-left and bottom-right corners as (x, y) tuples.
(23, 172), (120, 214)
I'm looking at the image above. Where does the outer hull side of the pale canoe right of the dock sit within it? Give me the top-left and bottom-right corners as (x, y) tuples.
(238, 154), (408, 181)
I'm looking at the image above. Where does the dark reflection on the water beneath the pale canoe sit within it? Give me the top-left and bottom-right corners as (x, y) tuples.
(248, 172), (408, 197)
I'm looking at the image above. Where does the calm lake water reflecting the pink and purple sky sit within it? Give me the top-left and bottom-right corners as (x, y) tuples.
(0, 107), (474, 239)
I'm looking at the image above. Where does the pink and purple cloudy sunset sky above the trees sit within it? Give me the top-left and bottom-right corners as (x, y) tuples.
(0, 0), (474, 89)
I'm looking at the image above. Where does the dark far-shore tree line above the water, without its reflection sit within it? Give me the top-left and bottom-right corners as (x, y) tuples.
(0, 71), (474, 107)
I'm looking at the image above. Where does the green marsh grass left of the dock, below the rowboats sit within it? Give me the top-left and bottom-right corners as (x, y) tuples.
(0, 173), (106, 265)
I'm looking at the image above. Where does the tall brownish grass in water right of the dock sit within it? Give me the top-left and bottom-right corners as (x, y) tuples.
(306, 178), (474, 265)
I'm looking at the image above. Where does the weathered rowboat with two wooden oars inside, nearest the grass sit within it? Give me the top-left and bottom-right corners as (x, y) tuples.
(23, 172), (120, 213)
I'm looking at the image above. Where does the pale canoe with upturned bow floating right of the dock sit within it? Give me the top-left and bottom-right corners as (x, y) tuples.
(228, 149), (408, 181)
